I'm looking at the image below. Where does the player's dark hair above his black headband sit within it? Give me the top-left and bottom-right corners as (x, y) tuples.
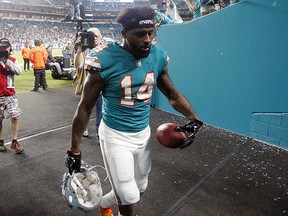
(116, 6), (155, 29)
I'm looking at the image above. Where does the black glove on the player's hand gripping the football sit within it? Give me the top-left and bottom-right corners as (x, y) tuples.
(176, 118), (203, 149)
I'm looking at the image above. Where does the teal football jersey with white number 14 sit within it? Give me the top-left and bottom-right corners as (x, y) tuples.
(85, 42), (169, 132)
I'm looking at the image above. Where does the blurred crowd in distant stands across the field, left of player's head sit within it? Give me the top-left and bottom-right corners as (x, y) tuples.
(0, 19), (120, 51)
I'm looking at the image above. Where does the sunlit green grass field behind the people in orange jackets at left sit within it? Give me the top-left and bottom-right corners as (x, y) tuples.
(12, 50), (72, 93)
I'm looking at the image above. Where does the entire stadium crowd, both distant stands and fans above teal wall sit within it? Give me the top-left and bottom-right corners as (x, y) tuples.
(0, 0), (239, 51)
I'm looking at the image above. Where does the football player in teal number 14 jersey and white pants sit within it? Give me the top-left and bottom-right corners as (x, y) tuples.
(66, 7), (202, 216)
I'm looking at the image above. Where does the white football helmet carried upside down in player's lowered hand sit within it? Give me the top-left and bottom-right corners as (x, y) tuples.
(61, 161), (103, 212)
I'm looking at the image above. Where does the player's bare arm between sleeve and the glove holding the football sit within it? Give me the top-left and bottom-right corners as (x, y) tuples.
(157, 67), (199, 120)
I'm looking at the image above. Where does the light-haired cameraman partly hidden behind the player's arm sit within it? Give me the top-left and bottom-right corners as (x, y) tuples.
(74, 28), (102, 138)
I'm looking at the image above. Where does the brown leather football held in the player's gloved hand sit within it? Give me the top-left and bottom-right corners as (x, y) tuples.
(156, 123), (188, 148)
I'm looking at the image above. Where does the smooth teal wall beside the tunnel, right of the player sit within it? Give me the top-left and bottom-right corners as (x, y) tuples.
(155, 0), (288, 148)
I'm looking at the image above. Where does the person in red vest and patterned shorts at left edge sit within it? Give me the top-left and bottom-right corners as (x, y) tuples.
(0, 38), (24, 154)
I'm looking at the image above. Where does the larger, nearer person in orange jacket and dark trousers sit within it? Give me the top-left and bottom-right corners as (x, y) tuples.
(29, 40), (48, 92)
